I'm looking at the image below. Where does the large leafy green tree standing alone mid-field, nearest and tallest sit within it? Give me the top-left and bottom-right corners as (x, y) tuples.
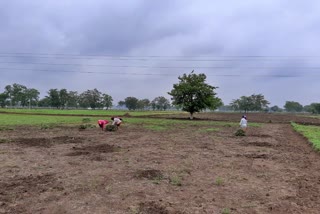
(168, 71), (222, 119)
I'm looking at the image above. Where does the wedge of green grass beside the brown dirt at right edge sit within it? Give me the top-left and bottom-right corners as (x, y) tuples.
(291, 123), (320, 151)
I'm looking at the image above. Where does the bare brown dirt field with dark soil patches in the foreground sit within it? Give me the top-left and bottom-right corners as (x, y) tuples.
(0, 115), (320, 214)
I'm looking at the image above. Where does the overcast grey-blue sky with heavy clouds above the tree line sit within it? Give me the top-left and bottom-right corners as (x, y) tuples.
(0, 0), (320, 107)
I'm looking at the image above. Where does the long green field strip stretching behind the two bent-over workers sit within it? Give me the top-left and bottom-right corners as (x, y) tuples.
(0, 111), (261, 132)
